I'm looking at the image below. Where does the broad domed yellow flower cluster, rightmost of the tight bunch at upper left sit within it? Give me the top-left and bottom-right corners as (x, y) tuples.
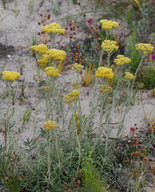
(46, 49), (66, 61)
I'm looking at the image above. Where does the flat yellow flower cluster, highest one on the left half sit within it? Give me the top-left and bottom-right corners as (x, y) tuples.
(42, 23), (65, 33)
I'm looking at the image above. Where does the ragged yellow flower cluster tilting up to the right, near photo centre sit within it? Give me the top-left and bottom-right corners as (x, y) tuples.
(61, 89), (81, 104)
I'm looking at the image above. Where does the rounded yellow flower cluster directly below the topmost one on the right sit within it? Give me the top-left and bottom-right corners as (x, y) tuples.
(101, 40), (119, 53)
